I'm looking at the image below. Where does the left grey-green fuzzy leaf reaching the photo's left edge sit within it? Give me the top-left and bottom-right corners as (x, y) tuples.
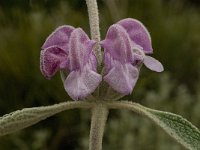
(0, 101), (91, 136)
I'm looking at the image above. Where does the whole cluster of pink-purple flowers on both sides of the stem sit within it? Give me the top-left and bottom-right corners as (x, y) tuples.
(40, 18), (163, 100)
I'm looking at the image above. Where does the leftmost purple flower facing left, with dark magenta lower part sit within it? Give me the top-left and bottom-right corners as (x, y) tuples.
(40, 25), (74, 78)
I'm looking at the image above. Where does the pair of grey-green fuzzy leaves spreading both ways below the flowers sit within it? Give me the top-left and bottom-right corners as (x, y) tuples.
(0, 101), (200, 150)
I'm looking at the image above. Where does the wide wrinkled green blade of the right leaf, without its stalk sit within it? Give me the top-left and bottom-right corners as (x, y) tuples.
(146, 109), (200, 150)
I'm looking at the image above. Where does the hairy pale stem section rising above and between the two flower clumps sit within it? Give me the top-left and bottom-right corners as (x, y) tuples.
(86, 0), (102, 65)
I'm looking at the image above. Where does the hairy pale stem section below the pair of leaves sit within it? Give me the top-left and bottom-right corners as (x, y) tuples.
(89, 103), (109, 150)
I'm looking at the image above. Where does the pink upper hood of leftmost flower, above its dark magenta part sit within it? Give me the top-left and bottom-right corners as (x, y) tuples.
(42, 25), (74, 52)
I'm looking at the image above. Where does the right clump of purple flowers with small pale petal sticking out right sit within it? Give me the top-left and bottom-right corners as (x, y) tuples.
(101, 19), (163, 95)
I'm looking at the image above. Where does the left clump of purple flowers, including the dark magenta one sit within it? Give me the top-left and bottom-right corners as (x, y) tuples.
(40, 25), (102, 100)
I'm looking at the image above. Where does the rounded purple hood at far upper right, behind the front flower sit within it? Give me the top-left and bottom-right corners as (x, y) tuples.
(117, 18), (153, 54)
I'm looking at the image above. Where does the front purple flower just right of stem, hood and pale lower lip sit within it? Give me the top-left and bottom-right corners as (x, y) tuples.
(100, 24), (139, 95)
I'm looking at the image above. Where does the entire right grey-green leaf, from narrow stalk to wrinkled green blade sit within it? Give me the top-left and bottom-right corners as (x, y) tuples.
(110, 101), (200, 150)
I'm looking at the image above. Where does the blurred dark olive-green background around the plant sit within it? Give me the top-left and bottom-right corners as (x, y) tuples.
(0, 0), (200, 150)
